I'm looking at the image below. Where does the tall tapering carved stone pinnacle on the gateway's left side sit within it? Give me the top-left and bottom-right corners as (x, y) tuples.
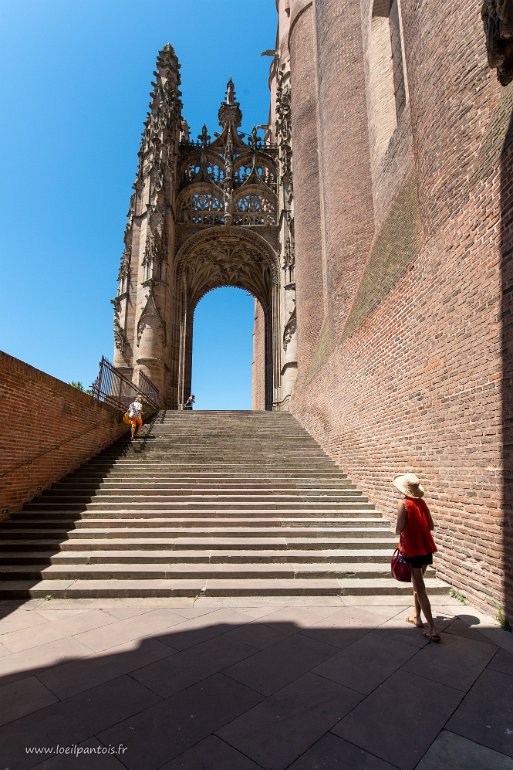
(113, 43), (182, 388)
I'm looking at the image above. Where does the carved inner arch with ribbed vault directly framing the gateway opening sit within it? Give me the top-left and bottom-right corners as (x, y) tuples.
(170, 226), (280, 409)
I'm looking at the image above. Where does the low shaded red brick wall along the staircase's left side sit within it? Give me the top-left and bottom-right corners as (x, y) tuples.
(0, 351), (128, 515)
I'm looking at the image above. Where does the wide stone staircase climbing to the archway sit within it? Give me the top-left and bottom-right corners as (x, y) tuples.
(0, 411), (448, 598)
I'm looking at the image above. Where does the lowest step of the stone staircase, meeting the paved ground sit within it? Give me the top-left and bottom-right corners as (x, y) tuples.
(0, 578), (449, 602)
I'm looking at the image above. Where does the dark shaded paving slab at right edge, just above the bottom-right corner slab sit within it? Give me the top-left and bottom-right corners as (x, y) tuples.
(446, 668), (513, 757)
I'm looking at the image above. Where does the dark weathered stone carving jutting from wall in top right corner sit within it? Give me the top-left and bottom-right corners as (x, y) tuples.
(481, 0), (513, 86)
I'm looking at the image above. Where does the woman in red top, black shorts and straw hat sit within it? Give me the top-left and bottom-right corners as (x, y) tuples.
(393, 473), (440, 642)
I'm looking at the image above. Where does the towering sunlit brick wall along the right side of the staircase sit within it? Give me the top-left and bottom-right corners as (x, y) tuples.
(291, 0), (513, 613)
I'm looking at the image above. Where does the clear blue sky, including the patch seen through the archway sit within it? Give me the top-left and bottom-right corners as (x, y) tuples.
(0, 0), (276, 409)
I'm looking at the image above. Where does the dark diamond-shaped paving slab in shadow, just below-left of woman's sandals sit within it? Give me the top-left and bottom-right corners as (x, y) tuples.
(314, 631), (416, 694)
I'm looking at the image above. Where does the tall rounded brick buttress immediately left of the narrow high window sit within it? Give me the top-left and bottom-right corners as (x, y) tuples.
(310, 0), (374, 342)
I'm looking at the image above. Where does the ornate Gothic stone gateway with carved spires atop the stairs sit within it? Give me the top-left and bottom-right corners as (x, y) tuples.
(113, 46), (297, 410)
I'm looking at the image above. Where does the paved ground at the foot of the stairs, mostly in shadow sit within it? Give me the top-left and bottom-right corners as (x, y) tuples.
(0, 598), (513, 770)
